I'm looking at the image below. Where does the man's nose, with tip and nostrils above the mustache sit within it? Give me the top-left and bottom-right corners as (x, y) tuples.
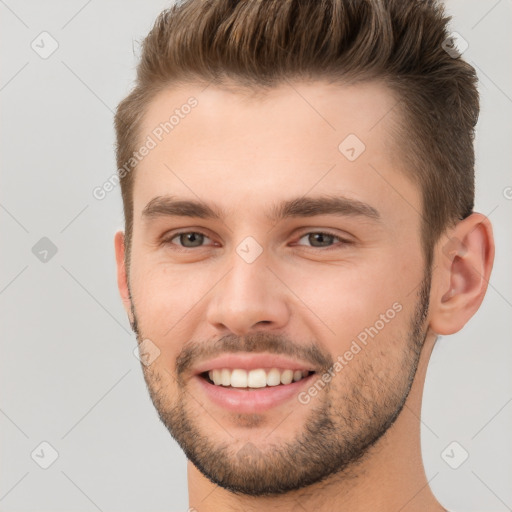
(207, 248), (290, 336)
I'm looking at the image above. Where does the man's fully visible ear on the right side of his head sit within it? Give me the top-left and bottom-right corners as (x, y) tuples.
(429, 213), (494, 335)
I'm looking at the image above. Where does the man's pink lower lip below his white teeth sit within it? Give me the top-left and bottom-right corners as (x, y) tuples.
(194, 373), (315, 414)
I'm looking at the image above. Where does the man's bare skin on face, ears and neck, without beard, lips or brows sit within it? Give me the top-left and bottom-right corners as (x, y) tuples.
(115, 81), (494, 512)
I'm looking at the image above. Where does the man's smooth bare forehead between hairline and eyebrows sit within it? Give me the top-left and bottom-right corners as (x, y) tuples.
(134, 82), (420, 230)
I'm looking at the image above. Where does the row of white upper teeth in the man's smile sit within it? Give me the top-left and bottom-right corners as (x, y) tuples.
(208, 368), (310, 388)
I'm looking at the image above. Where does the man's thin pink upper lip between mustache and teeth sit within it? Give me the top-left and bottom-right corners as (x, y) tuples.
(194, 353), (315, 374)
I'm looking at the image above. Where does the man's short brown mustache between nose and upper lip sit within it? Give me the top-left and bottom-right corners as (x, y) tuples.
(175, 332), (334, 378)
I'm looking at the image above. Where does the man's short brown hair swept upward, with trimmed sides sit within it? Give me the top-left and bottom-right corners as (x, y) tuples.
(115, 0), (479, 268)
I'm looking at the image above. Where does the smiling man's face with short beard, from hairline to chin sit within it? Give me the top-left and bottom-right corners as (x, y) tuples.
(121, 82), (430, 495)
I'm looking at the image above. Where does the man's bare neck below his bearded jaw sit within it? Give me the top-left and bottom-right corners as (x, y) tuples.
(187, 333), (444, 512)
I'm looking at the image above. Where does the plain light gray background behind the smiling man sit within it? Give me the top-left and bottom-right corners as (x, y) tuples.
(0, 0), (512, 512)
